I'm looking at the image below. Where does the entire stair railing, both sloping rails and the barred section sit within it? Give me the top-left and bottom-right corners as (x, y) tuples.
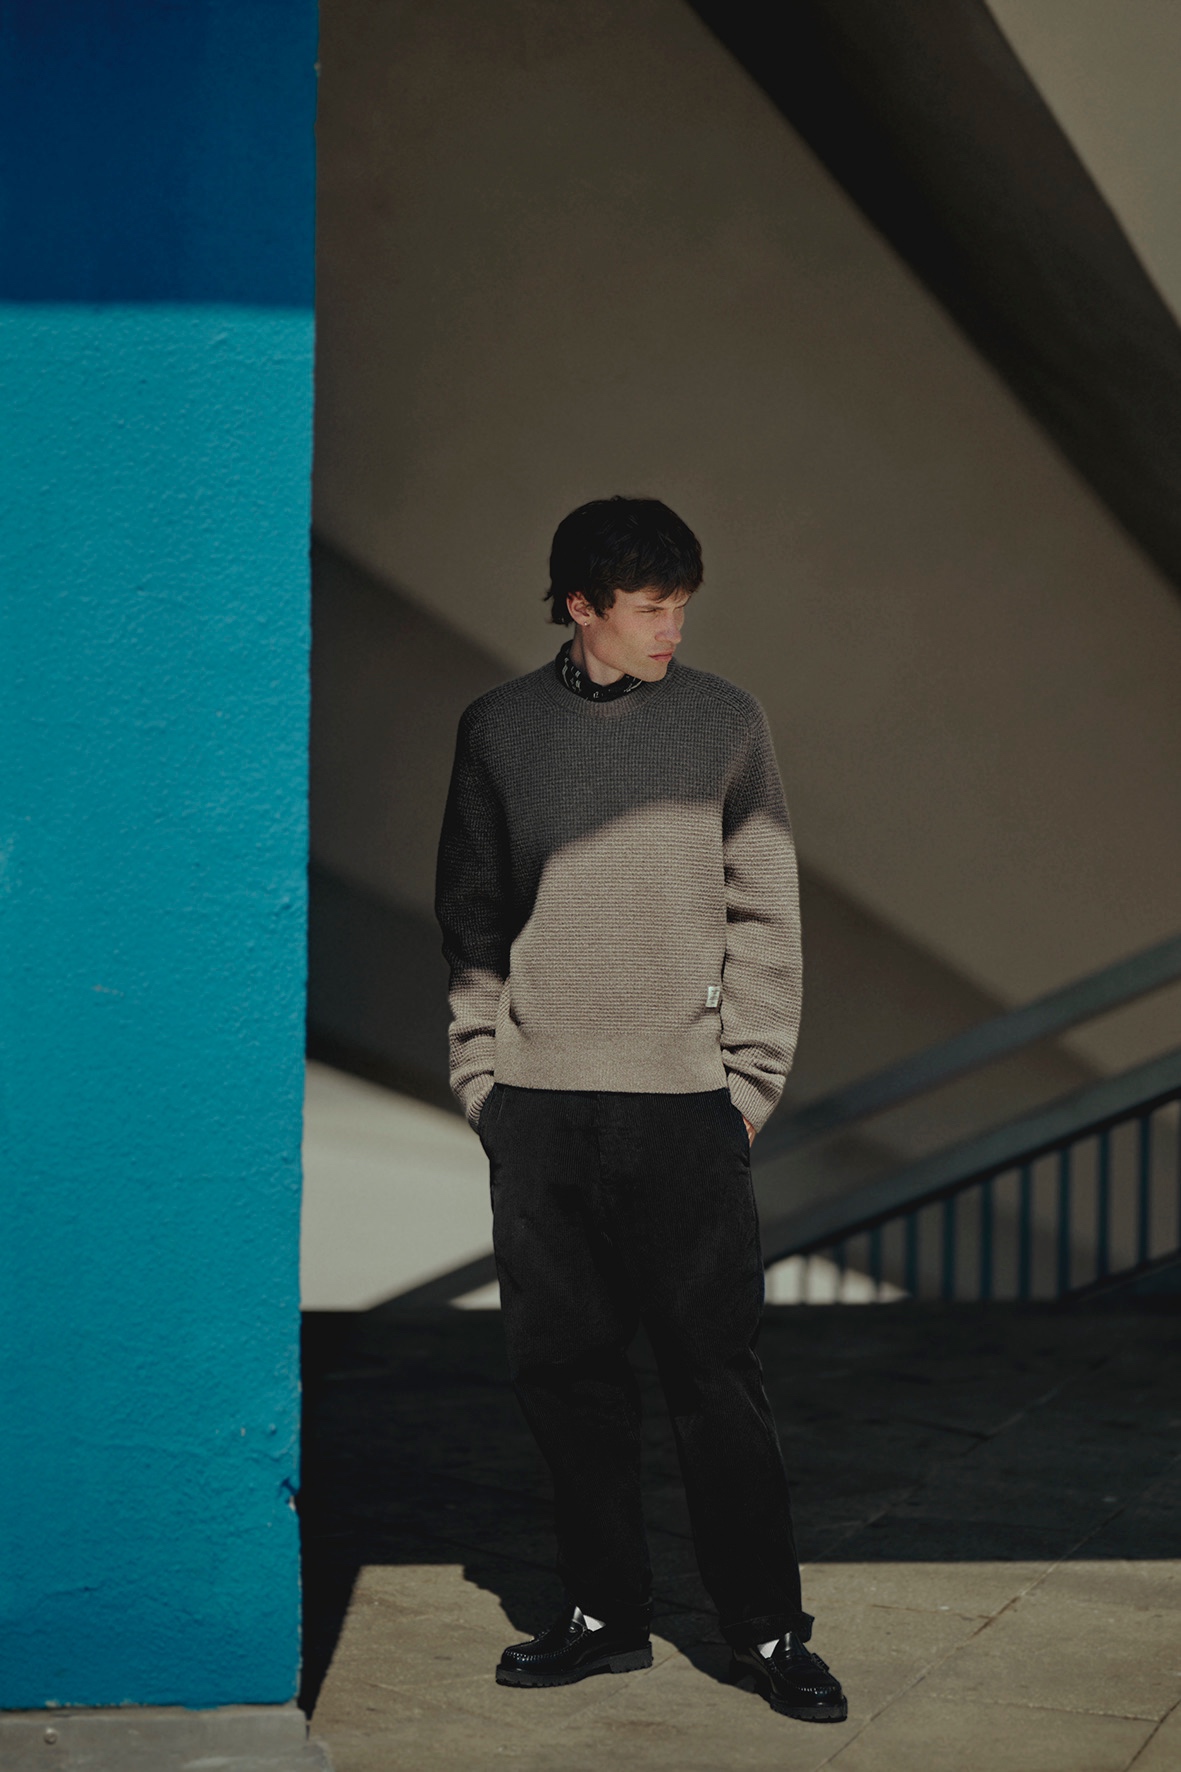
(755, 937), (1181, 1302)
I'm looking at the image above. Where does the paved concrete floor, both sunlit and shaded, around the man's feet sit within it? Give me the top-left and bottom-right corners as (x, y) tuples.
(301, 1304), (1181, 1772)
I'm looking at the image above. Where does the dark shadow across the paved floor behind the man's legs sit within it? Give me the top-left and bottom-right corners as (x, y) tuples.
(300, 1301), (1181, 1714)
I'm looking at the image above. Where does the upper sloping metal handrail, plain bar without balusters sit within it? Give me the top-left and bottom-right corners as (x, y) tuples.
(754, 936), (1181, 1166)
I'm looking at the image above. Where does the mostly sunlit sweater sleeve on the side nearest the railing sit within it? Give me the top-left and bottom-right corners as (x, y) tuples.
(722, 709), (803, 1131)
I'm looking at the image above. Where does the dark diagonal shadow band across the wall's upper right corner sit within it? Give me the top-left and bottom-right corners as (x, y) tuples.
(688, 0), (1181, 585)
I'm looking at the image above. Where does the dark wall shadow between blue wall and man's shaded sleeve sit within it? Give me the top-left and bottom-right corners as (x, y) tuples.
(309, 524), (511, 1108)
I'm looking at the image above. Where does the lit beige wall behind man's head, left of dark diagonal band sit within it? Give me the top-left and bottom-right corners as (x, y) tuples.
(316, 0), (1181, 1070)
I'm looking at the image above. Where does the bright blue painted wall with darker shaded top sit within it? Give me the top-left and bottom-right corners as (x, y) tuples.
(0, 0), (316, 1708)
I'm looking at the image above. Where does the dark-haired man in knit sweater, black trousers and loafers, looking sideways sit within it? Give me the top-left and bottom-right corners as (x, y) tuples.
(436, 498), (846, 1722)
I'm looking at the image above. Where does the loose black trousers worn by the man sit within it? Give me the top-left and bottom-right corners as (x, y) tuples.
(481, 1084), (812, 1646)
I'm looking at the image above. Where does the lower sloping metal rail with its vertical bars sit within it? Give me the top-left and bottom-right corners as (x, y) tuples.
(763, 1049), (1181, 1299)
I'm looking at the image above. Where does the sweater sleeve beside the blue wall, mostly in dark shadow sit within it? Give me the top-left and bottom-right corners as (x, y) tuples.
(434, 709), (511, 1125)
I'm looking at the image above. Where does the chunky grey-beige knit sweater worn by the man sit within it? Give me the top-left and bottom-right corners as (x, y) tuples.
(436, 661), (802, 1127)
